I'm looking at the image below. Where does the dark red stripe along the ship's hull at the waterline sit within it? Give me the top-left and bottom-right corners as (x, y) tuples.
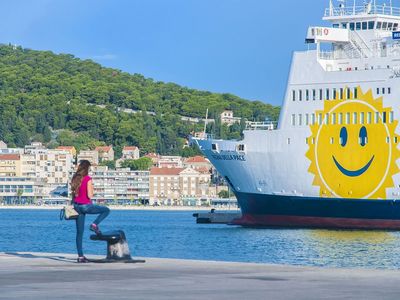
(232, 214), (400, 230)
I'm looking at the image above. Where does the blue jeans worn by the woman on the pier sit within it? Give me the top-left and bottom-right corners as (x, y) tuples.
(74, 203), (110, 256)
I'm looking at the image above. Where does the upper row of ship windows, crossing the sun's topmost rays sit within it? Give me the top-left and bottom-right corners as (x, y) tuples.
(292, 87), (392, 101)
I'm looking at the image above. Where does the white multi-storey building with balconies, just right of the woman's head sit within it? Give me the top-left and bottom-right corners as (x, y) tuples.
(91, 166), (150, 204)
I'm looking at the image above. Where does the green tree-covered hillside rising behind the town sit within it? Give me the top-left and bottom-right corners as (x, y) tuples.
(0, 45), (279, 154)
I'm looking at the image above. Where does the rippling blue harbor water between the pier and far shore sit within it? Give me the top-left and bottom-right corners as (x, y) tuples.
(0, 209), (400, 269)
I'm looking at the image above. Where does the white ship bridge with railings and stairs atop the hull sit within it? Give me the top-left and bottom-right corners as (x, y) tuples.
(306, 0), (400, 67)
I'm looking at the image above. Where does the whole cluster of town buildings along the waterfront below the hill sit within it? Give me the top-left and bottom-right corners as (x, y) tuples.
(0, 142), (225, 205)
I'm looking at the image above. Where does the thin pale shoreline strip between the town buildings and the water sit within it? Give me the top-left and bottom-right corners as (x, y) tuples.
(0, 205), (240, 212)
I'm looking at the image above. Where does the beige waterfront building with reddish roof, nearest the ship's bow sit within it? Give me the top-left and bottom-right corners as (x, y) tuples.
(150, 167), (210, 205)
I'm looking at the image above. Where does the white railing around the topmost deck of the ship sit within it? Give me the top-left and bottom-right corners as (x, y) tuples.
(324, 4), (400, 17)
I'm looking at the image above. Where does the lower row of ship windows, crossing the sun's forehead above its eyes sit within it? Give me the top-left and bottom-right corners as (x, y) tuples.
(291, 111), (394, 126)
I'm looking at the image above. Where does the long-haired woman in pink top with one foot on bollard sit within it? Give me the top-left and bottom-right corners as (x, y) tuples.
(71, 160), (110, 263)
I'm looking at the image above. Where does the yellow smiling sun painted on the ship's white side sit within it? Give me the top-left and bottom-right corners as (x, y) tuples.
(306, 87), (400, 199)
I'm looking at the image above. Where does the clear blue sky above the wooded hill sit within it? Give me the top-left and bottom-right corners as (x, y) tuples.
(0, 0), (328, 105)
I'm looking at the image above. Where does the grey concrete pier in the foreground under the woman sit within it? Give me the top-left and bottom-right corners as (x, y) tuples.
(0, 253), (400, 300)
